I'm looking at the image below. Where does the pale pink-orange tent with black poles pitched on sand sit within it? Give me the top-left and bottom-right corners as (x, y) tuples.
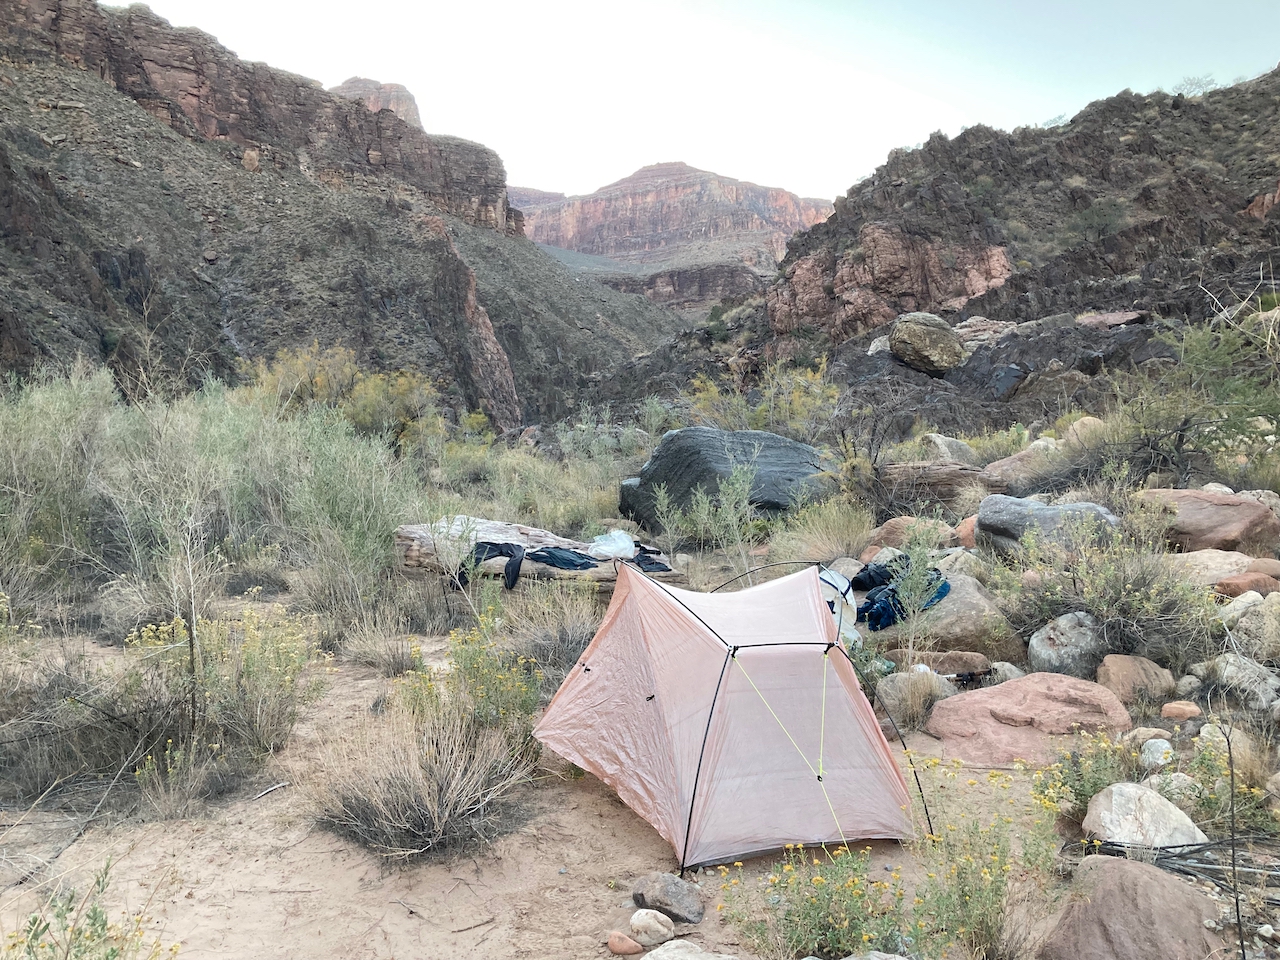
(534, 566), (913, 869)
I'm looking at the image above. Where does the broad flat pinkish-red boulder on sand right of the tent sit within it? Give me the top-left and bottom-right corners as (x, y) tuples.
(925, 673), (1133, 765)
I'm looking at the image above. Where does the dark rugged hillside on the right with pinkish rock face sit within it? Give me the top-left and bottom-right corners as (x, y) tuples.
(768, 72), (1280, 349)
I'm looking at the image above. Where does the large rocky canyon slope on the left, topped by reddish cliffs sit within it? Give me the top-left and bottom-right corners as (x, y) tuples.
(0, 0), (680, 426)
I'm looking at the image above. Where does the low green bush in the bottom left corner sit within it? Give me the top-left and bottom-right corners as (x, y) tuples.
(0, 865), (178, 960)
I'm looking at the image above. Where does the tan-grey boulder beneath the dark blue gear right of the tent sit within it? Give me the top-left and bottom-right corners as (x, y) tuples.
(876, 573), (1024, 660)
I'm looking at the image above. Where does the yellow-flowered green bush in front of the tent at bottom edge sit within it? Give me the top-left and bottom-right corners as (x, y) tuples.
(719, 844), (908, 960)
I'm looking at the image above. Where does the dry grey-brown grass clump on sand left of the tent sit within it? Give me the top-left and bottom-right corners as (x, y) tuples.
(314, 699), (534, 860)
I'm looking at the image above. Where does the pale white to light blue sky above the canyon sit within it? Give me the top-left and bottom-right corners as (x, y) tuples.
(135, 0), (1280, 200)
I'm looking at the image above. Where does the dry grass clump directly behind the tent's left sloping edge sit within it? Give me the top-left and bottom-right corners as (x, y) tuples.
(506, 580), (602, 701)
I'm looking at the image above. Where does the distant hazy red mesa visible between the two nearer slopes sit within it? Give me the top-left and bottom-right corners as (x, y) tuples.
(511, 163), (831, 315)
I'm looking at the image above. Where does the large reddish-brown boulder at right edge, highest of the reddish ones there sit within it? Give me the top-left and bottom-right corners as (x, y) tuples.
(1140, 489), (1280, 553)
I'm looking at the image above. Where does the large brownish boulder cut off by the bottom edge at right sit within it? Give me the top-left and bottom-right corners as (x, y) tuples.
(1036, 856), (1230, 960)
